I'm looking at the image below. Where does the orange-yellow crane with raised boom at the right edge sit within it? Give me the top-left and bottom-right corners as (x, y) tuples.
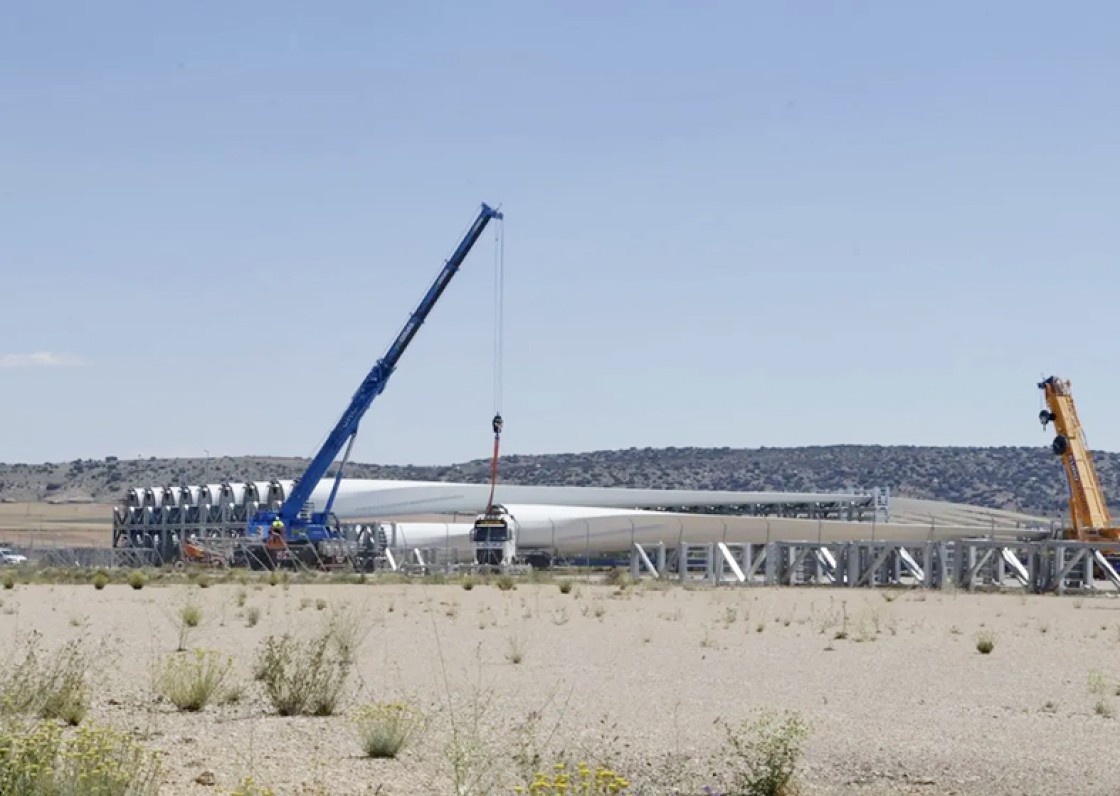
(1038, 376), (1120, 542)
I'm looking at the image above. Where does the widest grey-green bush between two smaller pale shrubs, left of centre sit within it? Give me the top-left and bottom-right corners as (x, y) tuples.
(255, 631), (349, 715)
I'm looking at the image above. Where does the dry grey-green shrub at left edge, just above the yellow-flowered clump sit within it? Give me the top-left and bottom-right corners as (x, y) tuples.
(0, 634), (90, 729)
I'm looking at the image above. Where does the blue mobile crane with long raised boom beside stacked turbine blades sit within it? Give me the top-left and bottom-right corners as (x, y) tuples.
(246, 203), (503, 555)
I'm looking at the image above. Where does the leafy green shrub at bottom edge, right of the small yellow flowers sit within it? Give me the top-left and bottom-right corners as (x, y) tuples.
(726, 712), (808, 796)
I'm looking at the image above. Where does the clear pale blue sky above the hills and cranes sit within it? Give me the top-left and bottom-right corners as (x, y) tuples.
(0, 0), (1120, 465)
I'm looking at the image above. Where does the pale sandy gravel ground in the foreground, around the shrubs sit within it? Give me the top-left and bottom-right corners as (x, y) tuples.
(0, 581), (1120, 796)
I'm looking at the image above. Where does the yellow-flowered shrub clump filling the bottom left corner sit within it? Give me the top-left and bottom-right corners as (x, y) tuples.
(0, 722), (160, 796)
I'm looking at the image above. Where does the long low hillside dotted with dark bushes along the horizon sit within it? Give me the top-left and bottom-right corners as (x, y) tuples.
(0, 446), (1120, 516)
